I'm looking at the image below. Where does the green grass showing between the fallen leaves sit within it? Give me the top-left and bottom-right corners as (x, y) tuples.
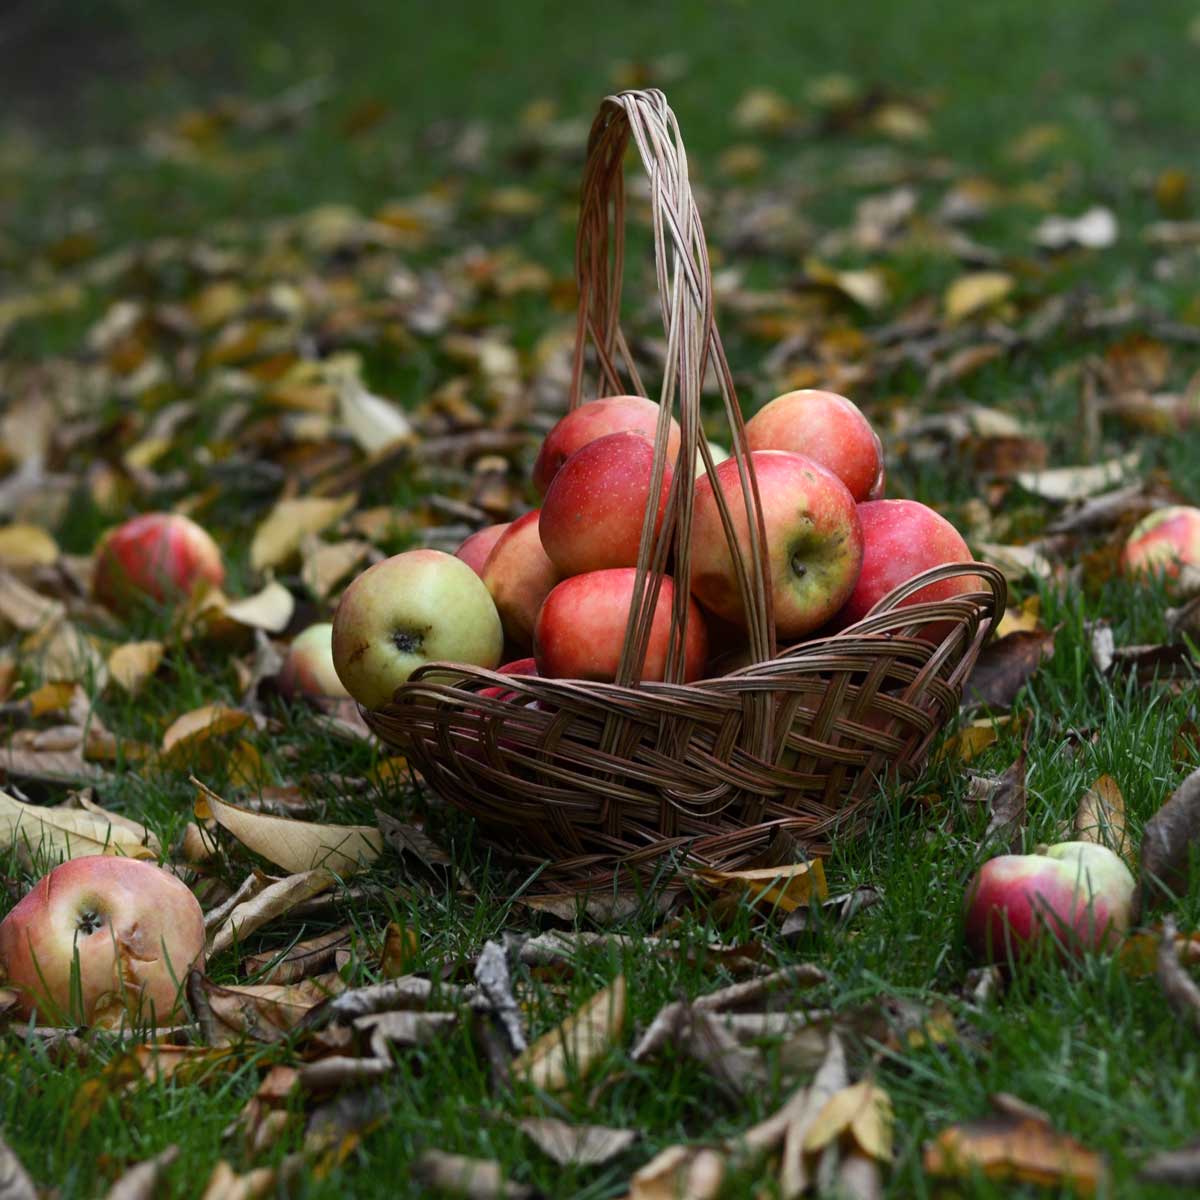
(0, 0), (1200, 1200)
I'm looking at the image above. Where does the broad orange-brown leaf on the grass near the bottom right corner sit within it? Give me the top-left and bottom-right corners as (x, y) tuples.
(924, 1112), (1108, 1195)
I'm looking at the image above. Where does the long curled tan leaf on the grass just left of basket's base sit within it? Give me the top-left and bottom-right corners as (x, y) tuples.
(192, 776), (383, 876)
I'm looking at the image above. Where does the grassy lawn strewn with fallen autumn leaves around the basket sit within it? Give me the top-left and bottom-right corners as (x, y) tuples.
(0, 0), (1200, 1200)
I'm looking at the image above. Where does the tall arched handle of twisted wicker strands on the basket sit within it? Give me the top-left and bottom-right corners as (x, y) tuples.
(570, 89), (775, 685)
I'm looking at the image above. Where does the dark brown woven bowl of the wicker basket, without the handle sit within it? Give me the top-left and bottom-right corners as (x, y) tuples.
(364, 563), (1006, 890)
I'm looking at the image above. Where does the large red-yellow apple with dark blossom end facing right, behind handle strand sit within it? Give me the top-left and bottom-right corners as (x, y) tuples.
(691, 450), (863, 638)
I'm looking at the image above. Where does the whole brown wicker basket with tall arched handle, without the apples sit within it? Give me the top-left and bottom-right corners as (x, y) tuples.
(364, 90), (1004, 889)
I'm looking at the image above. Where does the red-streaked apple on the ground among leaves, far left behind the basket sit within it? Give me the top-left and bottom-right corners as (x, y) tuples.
(92, 512), (224, 612)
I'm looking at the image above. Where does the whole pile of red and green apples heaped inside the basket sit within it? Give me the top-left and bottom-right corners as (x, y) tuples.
(332, 390), (977, 708)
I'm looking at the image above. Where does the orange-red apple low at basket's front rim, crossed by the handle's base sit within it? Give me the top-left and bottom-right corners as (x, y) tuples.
(533, 566), (708, 682)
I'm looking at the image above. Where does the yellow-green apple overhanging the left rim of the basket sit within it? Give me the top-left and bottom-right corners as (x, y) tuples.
(332, 550), (504, 708)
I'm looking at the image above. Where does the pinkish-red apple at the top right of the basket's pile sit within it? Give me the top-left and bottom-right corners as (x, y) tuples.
(746, 388), (883, 502)
